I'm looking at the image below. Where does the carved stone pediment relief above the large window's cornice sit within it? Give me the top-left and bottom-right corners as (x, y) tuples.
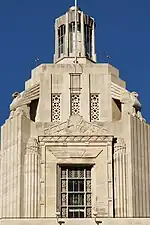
(44, 115), (107, 136)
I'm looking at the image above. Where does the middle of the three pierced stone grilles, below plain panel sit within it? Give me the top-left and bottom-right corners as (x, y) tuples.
(71, 94), (80, 115)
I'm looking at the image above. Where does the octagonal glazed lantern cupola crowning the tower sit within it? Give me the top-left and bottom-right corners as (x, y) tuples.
(54, 6), (96, 64)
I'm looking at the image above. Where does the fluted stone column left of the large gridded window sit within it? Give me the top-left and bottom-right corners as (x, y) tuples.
(24, 138), (40, 218)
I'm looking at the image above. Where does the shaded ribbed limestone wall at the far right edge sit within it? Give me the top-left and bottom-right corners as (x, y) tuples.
(131, 116), (150, 217)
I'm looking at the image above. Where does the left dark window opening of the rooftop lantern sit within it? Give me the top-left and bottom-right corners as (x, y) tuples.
(58, 24), (66, 57)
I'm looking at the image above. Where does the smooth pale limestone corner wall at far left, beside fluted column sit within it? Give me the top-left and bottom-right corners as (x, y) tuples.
(0, 114), (30, 217)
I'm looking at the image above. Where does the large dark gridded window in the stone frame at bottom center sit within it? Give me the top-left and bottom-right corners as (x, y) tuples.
(61, 165), (91, 218)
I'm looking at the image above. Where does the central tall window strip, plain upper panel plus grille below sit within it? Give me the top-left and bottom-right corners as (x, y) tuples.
(70, 73), (81, 115)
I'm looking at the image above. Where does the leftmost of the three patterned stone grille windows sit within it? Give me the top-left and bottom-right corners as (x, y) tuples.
(52, 94), (60, 122)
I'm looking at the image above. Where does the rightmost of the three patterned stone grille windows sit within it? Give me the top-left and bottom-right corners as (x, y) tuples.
(90, 94), (100, 122)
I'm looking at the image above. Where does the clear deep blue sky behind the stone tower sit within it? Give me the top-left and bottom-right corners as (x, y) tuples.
(0, 0), (150, 125)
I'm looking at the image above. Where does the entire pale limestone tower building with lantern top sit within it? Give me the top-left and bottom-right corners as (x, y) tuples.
(0, 4), (150, 225)
